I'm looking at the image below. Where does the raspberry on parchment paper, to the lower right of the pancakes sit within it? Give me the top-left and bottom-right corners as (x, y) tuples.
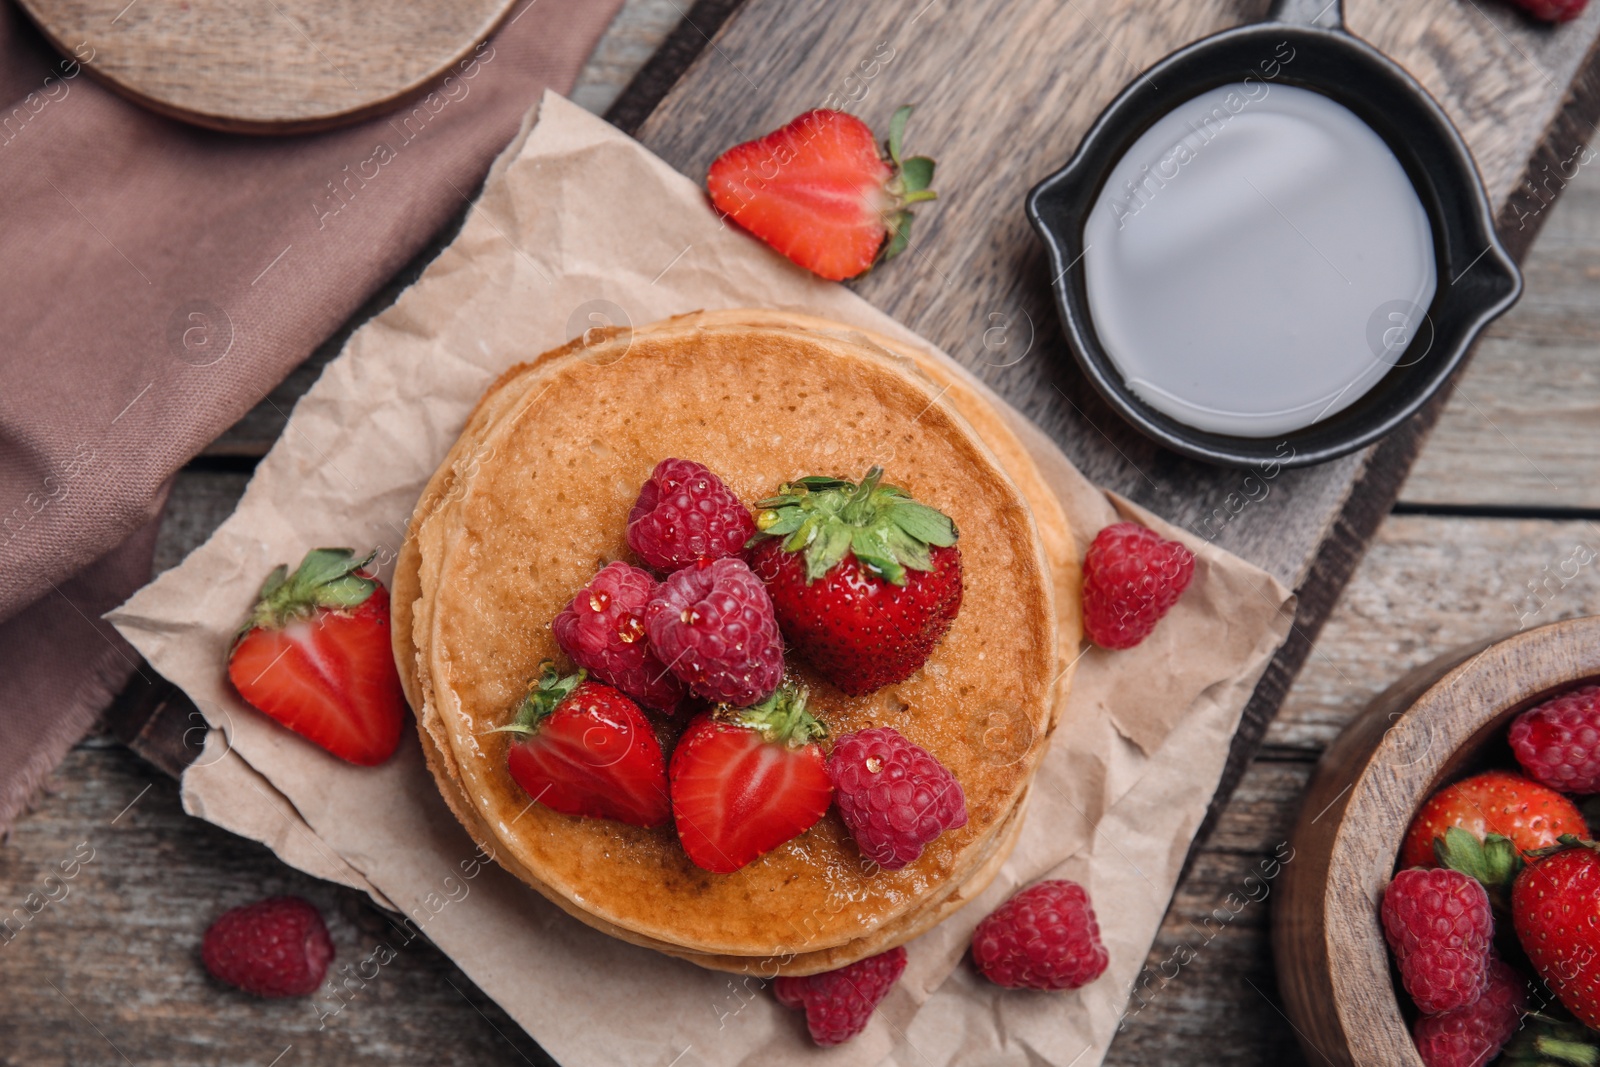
(973, 878), (1110, 989)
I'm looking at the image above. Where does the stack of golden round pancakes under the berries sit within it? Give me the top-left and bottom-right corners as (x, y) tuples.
(394, 310), (1080, 976)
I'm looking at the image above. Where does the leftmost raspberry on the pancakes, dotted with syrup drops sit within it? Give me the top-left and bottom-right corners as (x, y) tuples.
(550, 561), (683, 713)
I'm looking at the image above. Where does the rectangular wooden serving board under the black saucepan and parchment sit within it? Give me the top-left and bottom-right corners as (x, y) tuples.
(613, 0), (1600, 835)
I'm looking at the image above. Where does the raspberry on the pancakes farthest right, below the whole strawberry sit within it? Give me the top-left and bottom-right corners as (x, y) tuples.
(827, 726), (966, 870)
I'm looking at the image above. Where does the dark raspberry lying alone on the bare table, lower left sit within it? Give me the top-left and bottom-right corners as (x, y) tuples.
(200, 896), (333, 997)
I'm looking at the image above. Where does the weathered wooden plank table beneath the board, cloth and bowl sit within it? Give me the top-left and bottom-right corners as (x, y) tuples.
(0, 0), (1600, 1067)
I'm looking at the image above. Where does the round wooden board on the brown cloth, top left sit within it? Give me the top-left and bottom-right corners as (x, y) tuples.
(19, 0), (517, 133)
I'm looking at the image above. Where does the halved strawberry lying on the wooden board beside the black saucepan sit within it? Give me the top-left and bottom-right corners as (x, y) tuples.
(706, 107), (936, 282)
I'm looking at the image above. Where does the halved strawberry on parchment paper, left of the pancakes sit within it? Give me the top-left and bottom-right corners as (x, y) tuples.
(227, 549), (405, 766)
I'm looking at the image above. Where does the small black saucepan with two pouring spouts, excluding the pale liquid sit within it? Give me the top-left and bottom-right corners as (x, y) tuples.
(1027, 0), (1522, 467)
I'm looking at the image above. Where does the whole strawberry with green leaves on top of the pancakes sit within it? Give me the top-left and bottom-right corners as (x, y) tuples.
(747, 467), (962, 696)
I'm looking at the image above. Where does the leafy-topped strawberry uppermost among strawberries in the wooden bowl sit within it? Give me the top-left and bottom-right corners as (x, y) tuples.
(1400, 771), (1589, 893)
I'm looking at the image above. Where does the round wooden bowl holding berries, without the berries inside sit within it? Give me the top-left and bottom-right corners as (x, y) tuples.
(1272, 617), (1600, 1067)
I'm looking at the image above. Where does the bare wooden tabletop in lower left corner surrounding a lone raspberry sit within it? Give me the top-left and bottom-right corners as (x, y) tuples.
(0, 742), (554, 1067)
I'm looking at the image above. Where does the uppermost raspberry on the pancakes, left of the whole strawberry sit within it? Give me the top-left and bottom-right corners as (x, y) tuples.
(627, 459), (755, 571)
